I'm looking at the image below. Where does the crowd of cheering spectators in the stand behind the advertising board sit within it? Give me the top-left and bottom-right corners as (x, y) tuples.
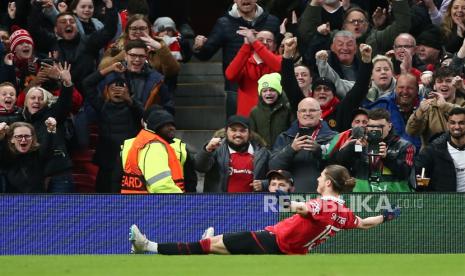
(0, 0), (465, 193)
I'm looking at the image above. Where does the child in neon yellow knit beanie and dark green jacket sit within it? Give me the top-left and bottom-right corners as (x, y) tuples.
(250, 73), (293, 148)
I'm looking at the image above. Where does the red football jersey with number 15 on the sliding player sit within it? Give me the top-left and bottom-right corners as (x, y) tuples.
(265, 196), (359, 254)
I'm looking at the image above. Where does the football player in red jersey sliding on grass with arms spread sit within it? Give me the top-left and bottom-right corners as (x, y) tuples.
(129, 165), (400, 255)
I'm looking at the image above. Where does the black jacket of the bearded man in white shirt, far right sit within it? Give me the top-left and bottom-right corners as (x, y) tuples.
(415, 133), (457, 192)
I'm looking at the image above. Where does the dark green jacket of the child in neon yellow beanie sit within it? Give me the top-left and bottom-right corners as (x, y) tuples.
(250, 95), (294, 148)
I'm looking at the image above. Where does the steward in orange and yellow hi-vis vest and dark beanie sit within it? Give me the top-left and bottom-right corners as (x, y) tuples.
(116, 108), (196, 194)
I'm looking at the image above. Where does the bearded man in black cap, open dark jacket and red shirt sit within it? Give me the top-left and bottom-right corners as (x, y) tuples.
(195, 115), (270, 193)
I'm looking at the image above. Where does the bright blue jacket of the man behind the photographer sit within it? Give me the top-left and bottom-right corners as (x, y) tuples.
(367, 91), (421, 152)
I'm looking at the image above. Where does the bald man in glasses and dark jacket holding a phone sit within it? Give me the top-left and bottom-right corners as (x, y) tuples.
(270, 97), (337, 193)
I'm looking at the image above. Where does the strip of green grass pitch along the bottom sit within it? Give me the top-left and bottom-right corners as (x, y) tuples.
(0, 254), (465, 276)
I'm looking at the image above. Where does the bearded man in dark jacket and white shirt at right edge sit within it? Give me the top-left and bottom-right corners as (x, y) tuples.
(415, 107), (465, 192)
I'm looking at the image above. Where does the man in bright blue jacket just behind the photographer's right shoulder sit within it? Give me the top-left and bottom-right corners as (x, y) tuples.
(367, 73), (421, 150)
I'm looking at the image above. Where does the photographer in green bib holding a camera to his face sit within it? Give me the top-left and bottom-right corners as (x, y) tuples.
(335, 109), (415, 192)
